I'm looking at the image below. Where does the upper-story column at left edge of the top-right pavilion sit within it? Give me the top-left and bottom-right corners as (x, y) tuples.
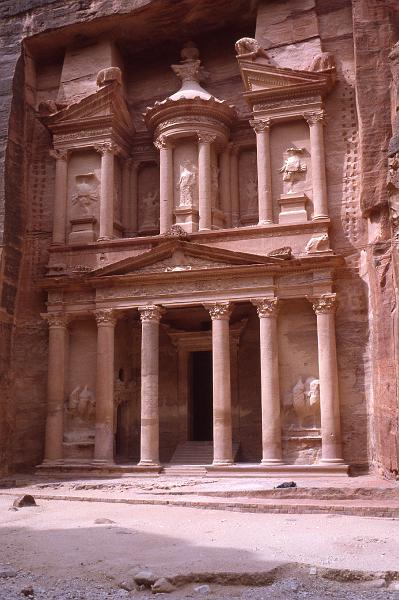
(250, 119), (273, 225)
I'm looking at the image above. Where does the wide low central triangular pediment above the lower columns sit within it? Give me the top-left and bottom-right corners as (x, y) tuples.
(90, 240), (283, 277)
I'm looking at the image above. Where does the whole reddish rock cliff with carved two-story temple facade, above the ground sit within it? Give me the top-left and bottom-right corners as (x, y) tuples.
(0, 0), (399, 477)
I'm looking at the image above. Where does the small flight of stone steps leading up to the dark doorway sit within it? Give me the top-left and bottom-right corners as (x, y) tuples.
(163, 442), (239, 477)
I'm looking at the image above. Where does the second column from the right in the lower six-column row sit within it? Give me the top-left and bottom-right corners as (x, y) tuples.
(252, 298), (282, 465)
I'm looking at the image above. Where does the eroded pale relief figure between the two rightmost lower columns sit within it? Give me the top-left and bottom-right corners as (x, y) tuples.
(292, 377), (320, 429)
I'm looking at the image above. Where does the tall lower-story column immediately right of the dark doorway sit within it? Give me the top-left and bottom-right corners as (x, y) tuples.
(205, 302), (233, 465)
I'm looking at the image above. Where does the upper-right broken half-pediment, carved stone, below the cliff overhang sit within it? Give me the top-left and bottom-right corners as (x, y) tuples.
(239, 60), (332, 98)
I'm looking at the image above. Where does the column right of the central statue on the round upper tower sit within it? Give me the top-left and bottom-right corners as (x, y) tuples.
(198, 133), (216, 231)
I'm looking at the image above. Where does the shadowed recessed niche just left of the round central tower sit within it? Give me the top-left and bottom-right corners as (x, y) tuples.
(137, 162), (159, 234)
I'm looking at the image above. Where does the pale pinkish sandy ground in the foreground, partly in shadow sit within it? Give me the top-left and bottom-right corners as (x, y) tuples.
(0, 496), (399, 600)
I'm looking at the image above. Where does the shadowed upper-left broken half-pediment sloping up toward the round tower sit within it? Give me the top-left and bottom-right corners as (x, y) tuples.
(44, 83), (133, 132)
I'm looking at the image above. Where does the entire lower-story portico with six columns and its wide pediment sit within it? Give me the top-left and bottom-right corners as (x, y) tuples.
(42, 240), (347, 473)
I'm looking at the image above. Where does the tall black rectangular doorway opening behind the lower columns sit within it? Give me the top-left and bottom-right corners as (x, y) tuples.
(190, 351), (213, 442)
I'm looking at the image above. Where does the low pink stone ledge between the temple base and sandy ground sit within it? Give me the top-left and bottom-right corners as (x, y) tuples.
(0, 473), (399, 519)
